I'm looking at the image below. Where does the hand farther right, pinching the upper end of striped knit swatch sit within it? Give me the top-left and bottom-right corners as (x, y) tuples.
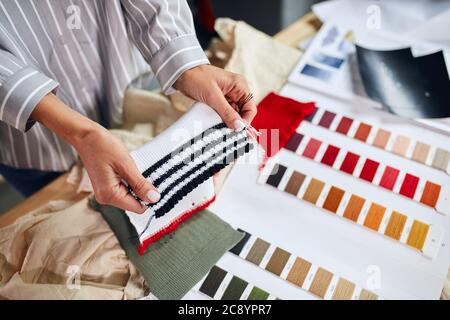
(174, 65), (256, 131)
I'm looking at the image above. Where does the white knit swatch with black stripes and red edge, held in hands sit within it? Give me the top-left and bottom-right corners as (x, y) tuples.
(127, 103), (253, 253)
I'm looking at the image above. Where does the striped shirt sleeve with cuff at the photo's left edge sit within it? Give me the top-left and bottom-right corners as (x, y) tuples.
(0, 50), (58, 131)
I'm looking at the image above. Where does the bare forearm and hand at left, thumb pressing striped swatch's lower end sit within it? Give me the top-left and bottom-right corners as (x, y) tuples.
(31, 94), (161, 213)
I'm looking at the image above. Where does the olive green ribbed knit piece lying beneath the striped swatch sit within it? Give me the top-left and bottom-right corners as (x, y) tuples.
(91, 201), (243, 300)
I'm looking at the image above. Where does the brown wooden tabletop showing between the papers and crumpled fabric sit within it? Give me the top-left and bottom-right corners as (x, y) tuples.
(0, 13), (321, 228)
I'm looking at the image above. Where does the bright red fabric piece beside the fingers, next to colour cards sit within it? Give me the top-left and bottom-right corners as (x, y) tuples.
(252, 92), (316, 158)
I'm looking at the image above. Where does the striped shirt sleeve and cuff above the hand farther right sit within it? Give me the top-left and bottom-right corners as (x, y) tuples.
(121, 0), (209, 93)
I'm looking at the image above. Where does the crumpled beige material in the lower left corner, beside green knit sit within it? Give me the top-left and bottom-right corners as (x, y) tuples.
(0, 199), (148, 300)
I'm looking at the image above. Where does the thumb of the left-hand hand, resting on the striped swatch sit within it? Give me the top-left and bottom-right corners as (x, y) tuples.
(117, 159), (161, 203)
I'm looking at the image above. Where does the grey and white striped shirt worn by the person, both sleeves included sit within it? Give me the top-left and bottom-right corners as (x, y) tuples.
(0, 0), (209, 171)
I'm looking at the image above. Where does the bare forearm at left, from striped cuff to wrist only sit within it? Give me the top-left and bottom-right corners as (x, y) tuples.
(31, 94), (103, 148)
